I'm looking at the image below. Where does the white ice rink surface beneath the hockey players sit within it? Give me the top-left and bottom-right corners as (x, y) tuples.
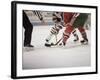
(22, 25), (91, 69)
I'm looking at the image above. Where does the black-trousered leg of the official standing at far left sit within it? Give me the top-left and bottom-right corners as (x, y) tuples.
(23, 11), (34, 48)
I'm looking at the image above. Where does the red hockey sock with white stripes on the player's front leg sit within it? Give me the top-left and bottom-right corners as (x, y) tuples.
(63, 25), (73, 43)
